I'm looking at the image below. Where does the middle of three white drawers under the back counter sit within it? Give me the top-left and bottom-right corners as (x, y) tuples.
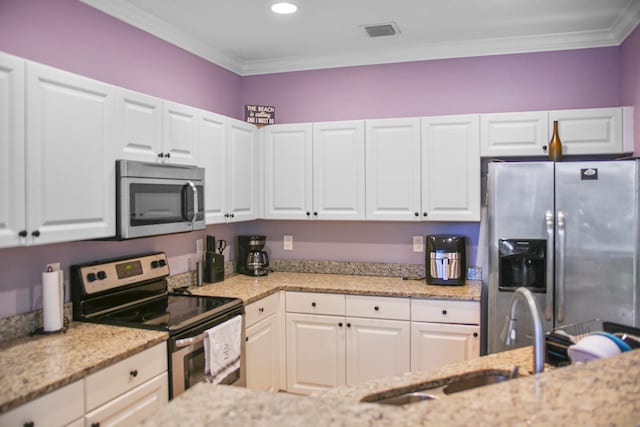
(346, 295), (411, 320)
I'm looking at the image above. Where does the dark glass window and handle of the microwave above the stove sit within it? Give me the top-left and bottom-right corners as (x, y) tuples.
(129, 184), (204, 226)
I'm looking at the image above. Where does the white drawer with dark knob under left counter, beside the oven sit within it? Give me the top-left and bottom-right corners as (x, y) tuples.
(85, 343), (167, 411)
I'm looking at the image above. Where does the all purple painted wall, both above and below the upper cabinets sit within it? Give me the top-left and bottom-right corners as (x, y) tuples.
(0, 0), (640, 318)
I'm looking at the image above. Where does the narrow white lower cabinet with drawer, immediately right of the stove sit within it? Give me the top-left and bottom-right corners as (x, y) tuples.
(244, 293), (285, 391)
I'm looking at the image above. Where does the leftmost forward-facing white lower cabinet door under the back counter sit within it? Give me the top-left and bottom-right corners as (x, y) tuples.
(286, 313), (345, 394)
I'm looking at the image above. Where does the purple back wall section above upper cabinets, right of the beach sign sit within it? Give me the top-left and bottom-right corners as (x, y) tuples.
(242, 47), (620, 123)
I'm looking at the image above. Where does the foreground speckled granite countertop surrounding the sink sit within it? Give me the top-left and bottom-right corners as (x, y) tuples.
(142, 347), (640, 427)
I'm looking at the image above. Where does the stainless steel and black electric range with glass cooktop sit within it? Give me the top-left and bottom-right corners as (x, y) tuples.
(71, 252), (243, 398)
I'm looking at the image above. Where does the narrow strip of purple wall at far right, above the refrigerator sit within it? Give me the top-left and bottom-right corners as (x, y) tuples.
(620, 26), (640, 156)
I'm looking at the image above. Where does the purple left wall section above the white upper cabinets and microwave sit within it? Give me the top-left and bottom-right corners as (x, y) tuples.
(0, 0), (241, 118)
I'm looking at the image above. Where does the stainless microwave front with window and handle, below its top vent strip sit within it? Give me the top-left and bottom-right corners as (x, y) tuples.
(118, 177), (205, 239)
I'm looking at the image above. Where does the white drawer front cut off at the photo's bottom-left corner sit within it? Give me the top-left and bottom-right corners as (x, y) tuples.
(0, 380), (84, 427)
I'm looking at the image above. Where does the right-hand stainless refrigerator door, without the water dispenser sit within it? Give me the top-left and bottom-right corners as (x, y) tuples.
(556, 161), (638, 326)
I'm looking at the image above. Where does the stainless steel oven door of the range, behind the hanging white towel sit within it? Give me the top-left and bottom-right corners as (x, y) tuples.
(169, 307), (243, 399)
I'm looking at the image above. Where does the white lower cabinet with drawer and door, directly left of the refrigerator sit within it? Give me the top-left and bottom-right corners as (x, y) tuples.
(411, 300), (480, 371)
